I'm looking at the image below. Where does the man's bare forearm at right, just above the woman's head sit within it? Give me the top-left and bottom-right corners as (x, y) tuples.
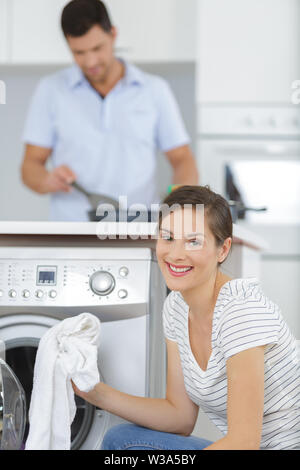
(165, 145), (199, 185)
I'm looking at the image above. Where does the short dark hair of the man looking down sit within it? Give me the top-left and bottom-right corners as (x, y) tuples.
(61, 0), (112, 37)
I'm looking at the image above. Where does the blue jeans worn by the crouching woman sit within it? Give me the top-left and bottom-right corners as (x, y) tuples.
(101, 423), (212, 450)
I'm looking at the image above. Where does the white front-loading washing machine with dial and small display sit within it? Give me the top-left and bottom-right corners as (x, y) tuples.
(0, 246), (167, 450)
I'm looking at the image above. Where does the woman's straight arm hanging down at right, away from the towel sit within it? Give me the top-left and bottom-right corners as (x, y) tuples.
(205, 346), (264, 450)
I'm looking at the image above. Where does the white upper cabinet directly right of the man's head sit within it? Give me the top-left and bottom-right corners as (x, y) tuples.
(106, 0), (197, 62)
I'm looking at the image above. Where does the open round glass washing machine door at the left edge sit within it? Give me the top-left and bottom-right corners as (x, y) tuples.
(0, 358), (26, 450)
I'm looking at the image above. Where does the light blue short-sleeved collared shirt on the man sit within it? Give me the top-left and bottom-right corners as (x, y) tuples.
(23, 62), (189, 221)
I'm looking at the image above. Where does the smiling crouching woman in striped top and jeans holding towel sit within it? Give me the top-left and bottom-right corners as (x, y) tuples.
(74, 186), (300, 450)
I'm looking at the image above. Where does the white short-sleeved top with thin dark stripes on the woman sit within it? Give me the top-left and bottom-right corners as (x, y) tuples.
(163, 278), (300, 449)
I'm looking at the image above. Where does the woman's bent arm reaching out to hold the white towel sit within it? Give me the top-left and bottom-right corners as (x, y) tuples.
(73, 340), (198, 435)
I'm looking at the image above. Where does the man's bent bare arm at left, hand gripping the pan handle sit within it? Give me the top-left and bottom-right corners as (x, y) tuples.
(21, 144), (76, 194)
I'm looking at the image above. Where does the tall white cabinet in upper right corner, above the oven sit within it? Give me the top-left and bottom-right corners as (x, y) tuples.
(197, 0), (300, 103)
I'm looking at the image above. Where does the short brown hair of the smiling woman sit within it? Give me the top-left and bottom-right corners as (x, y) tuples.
(159, 185), (232, 265)
